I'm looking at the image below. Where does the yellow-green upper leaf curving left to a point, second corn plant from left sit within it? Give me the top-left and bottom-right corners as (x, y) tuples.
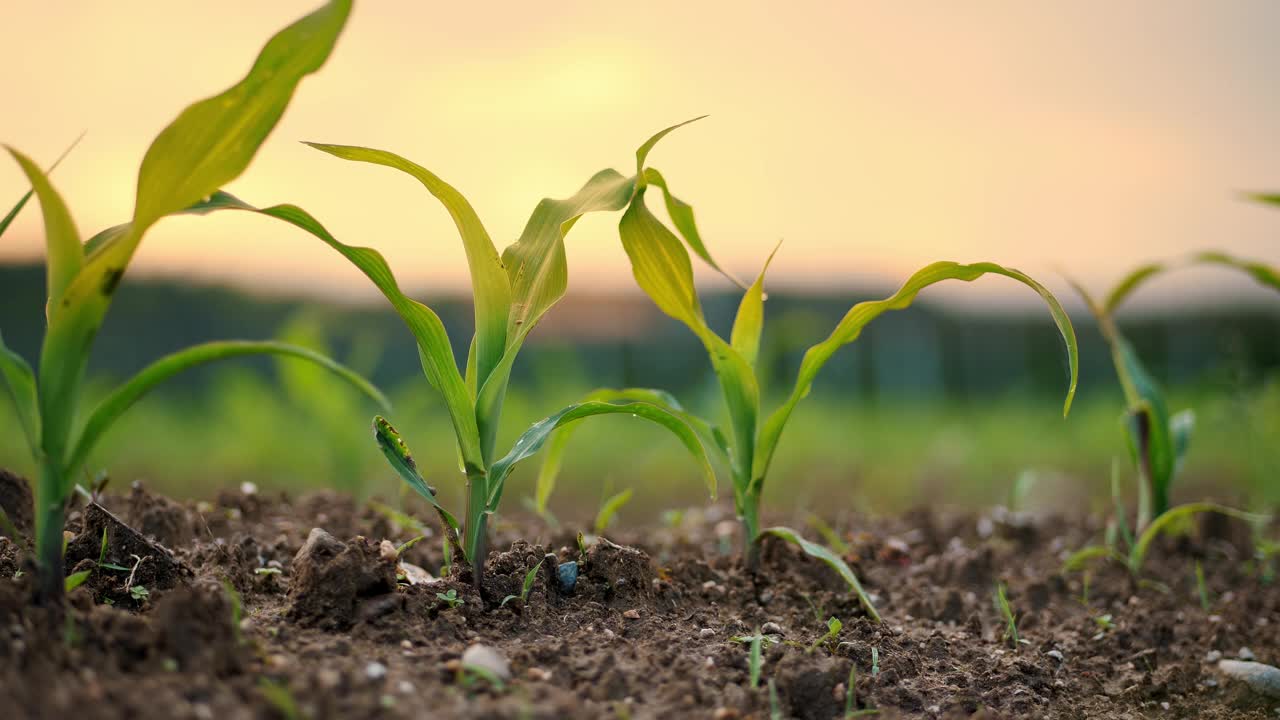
(306, 142), (511, 399)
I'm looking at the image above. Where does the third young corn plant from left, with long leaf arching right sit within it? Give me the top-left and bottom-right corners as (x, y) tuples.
(538, 117), (1078, 616)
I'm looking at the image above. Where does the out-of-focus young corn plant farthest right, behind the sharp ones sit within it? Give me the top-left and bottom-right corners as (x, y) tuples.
(1073, 252), (1280, 530)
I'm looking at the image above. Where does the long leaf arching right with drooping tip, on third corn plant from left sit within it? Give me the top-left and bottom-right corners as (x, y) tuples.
(753, 261), (1079, 483)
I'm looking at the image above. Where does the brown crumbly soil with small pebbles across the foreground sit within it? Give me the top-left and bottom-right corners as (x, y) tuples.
(0, 475), (1280, 720)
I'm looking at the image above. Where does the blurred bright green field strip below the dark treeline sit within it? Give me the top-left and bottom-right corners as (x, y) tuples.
(0, 356), (1280, 521)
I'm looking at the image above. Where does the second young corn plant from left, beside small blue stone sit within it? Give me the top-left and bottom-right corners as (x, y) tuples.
(189, 121), (716, 588)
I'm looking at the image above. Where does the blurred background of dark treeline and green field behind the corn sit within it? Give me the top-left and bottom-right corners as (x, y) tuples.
(0, 260), (1280, 521)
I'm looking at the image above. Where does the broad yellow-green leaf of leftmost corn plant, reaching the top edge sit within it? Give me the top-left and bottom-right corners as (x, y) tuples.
(40, 0), (351, 456)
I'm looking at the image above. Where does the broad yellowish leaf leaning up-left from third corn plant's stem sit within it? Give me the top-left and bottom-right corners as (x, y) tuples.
(618, 190), (760, 481)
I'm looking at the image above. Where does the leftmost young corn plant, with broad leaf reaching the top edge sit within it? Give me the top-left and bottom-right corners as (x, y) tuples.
(0, 1), (371, 605)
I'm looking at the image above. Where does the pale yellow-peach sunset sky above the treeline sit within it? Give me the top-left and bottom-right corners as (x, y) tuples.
(0, 0), (1280, 306)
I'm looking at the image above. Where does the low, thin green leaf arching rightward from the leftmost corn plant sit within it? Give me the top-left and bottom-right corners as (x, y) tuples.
(67, 340), (389, 477)
